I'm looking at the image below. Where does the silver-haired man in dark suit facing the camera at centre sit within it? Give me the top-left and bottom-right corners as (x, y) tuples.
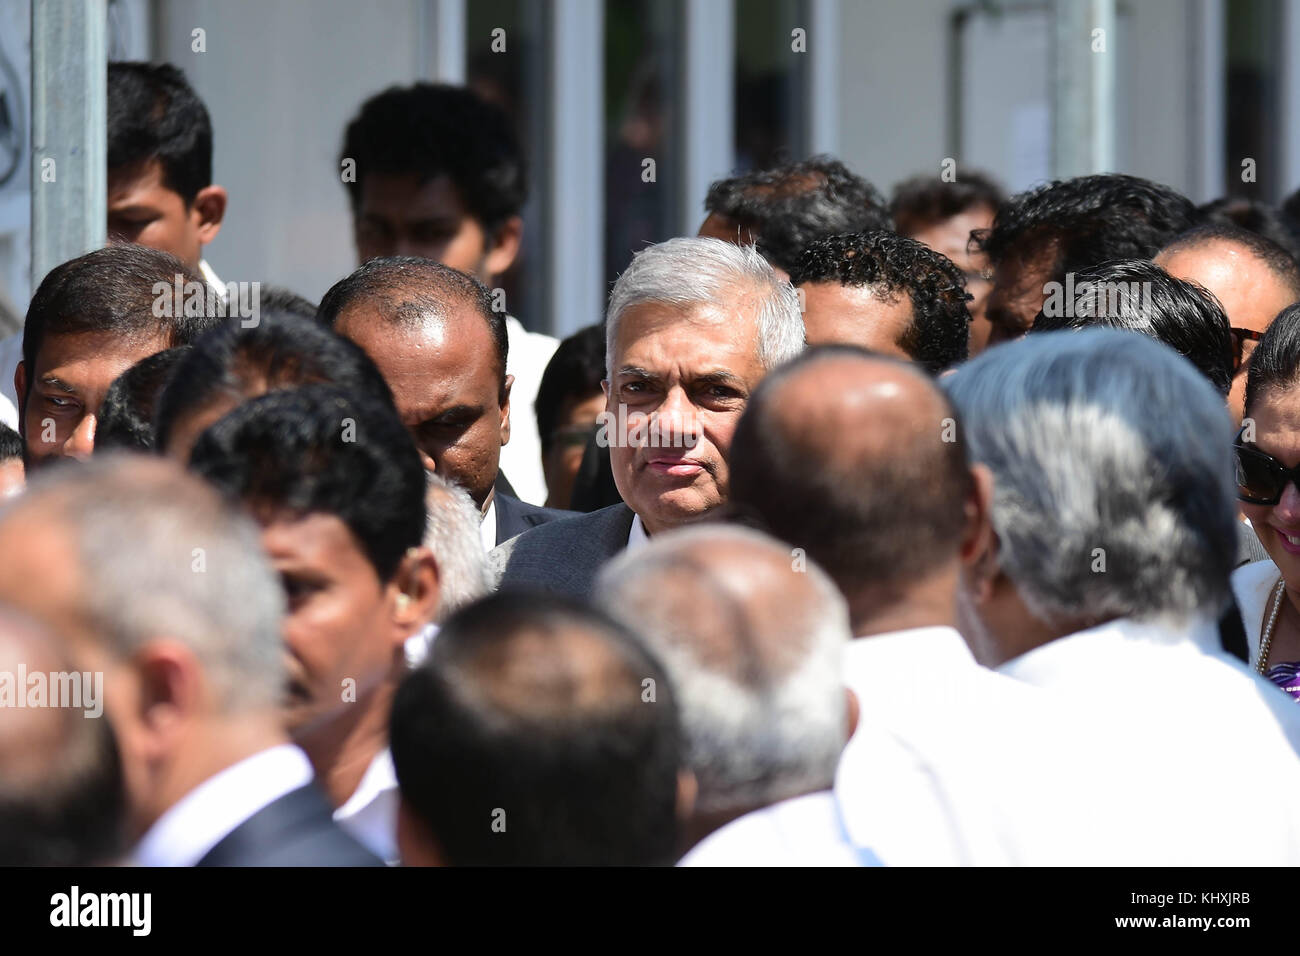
(489, 238), (803, 596)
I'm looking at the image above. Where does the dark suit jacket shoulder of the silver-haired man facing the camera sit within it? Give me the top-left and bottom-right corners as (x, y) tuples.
(488, 503), (633, 597)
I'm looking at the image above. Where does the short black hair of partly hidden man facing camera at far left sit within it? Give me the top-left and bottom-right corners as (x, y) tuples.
(22, 243), (213, 398)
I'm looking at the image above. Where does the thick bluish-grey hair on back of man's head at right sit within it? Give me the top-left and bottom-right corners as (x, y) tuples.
(943, 329), (1236, 624)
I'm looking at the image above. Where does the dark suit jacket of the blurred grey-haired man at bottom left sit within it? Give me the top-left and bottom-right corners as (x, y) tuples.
(198, 784), (384, 866)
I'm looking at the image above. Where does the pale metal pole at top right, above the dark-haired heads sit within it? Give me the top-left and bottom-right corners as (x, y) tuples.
(1052, 0), (1118, 178)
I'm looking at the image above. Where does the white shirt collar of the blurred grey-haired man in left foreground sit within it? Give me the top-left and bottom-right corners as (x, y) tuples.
(133, 744), (313, 866)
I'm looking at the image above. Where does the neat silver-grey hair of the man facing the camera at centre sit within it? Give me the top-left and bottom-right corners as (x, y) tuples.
(605, 238), (803, 376)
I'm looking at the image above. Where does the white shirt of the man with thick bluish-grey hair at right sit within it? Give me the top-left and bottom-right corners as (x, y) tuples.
(1000, 619), (1300, 866)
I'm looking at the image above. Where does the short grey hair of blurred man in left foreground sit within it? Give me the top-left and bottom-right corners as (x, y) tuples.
(22, 454), (286, 713)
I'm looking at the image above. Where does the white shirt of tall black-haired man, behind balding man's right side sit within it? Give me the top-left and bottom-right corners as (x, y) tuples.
(501, 315), (559, 505)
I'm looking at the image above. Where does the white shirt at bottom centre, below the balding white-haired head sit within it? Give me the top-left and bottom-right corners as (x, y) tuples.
(677, 791), (879, 866)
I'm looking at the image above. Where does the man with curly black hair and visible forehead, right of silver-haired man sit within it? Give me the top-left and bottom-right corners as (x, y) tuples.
(790, 232), (970, 375)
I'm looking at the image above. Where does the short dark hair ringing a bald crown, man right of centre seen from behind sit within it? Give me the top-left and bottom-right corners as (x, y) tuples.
(729, 345), (971, 601)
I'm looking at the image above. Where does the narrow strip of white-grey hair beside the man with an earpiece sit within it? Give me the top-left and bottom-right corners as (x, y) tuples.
(424, 472), (491, 624)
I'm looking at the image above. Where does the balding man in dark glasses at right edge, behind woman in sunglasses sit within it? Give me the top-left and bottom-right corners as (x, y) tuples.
(1156, 224), (1300, 424)
